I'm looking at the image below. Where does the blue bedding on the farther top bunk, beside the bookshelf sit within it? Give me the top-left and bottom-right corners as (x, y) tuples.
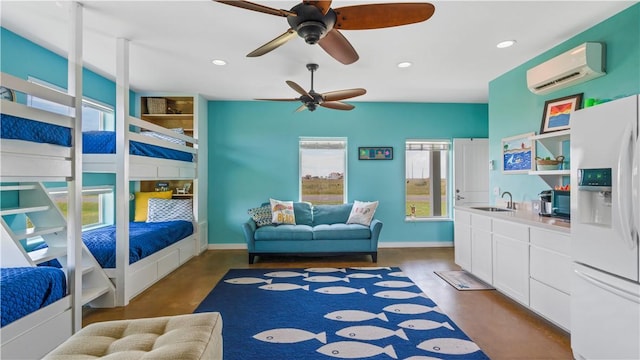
(82, 131), (193, 162)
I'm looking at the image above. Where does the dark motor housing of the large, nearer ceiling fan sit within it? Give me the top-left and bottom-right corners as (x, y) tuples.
(287, 3), (336, 45)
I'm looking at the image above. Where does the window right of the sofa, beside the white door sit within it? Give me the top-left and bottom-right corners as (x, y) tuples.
(405, 140), (451, 219)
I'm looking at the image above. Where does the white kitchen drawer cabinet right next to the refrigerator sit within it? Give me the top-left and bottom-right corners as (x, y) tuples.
(530, 227), (572, 331)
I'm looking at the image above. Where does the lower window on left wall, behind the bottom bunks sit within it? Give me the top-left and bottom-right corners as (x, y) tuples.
(48, 186), (114, 229)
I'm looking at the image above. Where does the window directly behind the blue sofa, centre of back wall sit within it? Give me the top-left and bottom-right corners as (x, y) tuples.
(300, 138), (347, 205)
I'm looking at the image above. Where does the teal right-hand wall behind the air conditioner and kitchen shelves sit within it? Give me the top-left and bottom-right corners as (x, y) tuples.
(489, 4), (640, 203)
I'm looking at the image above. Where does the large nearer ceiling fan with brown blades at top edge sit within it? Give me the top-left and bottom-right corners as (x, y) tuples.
(215, 0), (435, 65)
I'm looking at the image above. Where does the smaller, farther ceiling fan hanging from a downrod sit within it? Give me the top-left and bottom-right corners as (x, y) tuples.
(256, 64), (367, 111)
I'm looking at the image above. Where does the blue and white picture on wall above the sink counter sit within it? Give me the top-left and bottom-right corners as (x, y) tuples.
(502, 132), (536, 174)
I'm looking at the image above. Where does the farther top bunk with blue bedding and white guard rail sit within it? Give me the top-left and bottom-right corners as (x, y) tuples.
(82, 116), (198, 180)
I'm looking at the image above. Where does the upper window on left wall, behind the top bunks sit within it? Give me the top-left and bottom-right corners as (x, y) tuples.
(27, 77), (115, 131)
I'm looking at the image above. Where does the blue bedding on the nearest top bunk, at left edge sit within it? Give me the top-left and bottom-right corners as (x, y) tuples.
(0, 114), (71, 146)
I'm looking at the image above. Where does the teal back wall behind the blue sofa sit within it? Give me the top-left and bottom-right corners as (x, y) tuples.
(208, 101), (488, 244)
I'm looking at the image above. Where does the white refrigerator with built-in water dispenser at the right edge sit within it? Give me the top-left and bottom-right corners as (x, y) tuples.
(570, 95), (640, 360)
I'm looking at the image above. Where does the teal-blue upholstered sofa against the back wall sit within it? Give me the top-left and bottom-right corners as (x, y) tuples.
(242, 202), (382, 264)
